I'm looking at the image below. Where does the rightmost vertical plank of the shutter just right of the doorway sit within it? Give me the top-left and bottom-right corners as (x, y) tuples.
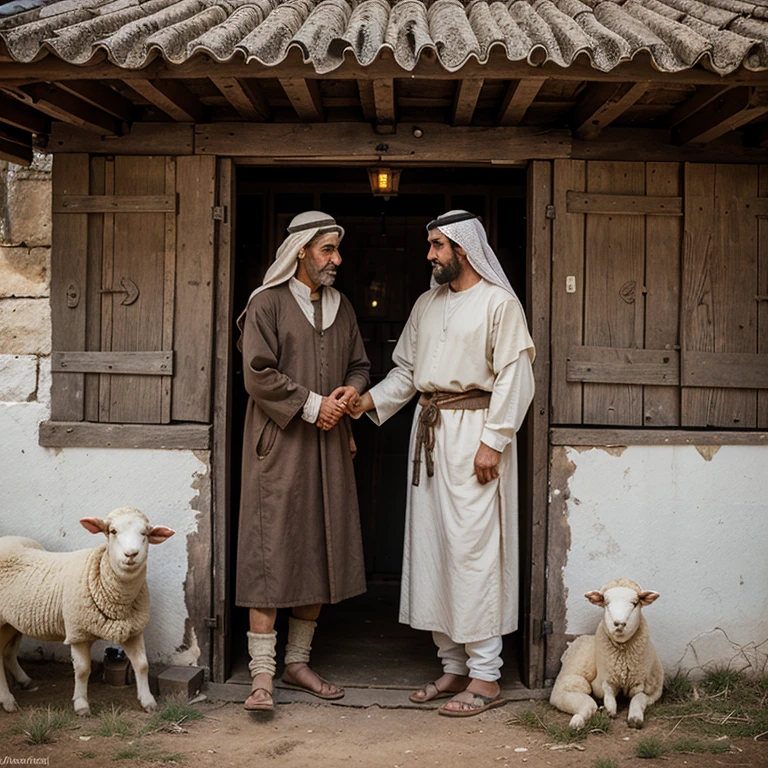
(643, 163), (683, 427)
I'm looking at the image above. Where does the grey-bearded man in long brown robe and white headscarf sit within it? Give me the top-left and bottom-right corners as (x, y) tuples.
(236, 211), (370, 710)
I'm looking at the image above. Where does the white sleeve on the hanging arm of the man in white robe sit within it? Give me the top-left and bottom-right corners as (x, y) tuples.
(480, 302), (534, 451)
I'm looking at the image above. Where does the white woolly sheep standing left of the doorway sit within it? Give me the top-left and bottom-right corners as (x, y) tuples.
(0, 507), (174, 715)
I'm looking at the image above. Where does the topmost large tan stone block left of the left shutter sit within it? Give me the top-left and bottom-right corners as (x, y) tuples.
(5, 175), (52, 246)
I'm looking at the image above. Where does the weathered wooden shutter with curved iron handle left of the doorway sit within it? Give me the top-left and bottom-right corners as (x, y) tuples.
(41, 155), (216, 447)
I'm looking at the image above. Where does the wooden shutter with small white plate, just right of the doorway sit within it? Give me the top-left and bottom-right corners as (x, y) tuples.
(552, 160), (682, 427)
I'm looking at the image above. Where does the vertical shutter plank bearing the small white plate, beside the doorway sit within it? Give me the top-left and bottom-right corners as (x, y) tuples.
(550, 160), (586, 424)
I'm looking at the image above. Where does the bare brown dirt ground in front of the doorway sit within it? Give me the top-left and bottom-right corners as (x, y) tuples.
(0, 664), (768, 768)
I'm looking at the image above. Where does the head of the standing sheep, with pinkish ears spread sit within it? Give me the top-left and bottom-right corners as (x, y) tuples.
(80, 507), (175, 575)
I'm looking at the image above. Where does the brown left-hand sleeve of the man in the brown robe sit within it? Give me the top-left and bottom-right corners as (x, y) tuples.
(243, 291), (309, 429)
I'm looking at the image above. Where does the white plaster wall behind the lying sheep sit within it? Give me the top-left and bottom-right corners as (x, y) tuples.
(556, 446), (768, 676)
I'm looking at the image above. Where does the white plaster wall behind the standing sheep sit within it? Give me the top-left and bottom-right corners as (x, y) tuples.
(0, 402), (208, 664)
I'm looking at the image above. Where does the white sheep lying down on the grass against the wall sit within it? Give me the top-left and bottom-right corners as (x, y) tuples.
(549, 579), (664, 729)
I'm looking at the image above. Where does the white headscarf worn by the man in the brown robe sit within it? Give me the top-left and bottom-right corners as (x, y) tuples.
(237, 211), (344, 331)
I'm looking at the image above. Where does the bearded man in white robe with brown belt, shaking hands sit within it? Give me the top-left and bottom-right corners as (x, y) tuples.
(353, 211), (534, 717)
